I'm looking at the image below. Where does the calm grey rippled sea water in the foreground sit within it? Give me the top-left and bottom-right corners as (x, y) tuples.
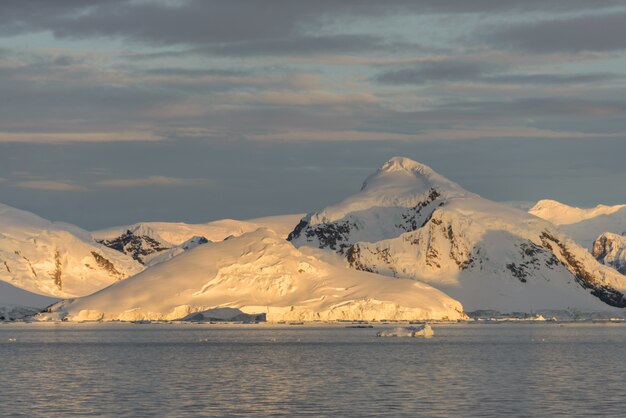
(0, 323), (626, 417)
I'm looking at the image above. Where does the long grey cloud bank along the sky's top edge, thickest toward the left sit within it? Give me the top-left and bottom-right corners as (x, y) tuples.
(0, 0), (623, 49)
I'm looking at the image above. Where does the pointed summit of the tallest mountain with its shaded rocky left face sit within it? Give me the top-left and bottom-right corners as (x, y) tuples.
(289, 157), (476, 252)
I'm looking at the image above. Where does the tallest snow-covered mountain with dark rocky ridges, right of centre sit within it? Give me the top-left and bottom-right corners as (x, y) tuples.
(289, 157), (626, 312)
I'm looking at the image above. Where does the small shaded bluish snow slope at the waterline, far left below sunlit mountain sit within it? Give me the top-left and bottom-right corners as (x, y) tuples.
(0, 281), (58, 321)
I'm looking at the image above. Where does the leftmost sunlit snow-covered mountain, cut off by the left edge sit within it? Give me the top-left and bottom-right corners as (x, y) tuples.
(0, 204), (142, 297)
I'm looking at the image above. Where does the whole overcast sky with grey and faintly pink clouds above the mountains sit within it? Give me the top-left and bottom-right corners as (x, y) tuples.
(0, 0), (626, 229)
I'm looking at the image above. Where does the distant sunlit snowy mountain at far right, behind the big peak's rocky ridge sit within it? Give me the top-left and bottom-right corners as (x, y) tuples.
(528, 200), (626, 250)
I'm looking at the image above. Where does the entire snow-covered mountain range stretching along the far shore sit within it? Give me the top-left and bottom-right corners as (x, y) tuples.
(0, 157), (626, 321)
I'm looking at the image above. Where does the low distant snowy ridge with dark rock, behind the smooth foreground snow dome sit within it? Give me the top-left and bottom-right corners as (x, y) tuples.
(92, 214), (302, 267)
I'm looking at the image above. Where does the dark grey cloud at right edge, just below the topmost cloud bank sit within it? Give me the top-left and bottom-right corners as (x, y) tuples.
(482, 12), (626, 53)
